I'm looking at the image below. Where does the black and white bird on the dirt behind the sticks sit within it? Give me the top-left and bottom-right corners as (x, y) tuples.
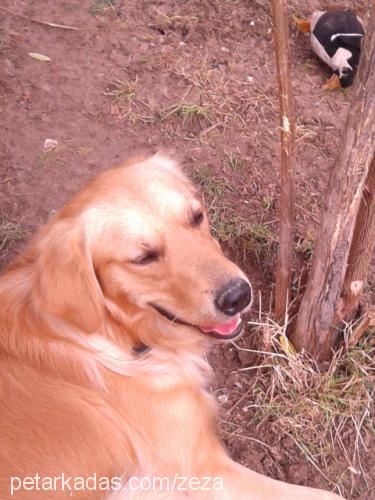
(297, 9), (365, 89)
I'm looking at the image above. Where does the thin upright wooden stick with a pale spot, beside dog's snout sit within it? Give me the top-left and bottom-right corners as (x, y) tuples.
(272, 0), (295, 321)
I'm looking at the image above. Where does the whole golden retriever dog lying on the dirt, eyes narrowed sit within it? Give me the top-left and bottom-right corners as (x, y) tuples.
(0, 155), (338, 500)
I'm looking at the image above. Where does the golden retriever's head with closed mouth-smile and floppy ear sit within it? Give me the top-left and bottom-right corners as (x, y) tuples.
(36, 156), (251, 339)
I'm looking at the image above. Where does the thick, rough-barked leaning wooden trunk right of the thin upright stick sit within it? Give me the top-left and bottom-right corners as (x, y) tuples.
(291, 5), (375, 359)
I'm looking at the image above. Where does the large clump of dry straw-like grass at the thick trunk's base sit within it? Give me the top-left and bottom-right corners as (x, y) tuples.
(229, 319), (375, 498)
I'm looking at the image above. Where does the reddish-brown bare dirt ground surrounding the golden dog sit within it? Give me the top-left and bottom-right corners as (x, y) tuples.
(0, 0), (375, 499)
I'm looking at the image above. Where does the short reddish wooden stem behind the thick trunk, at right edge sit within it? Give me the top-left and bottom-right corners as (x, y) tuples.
(341, 154), (375, 321)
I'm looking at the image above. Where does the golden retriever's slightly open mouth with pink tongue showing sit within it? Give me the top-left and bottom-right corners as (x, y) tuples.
(150, 304), (243, 340)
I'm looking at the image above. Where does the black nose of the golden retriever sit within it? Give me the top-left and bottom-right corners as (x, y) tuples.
(215, 278), (251, 316)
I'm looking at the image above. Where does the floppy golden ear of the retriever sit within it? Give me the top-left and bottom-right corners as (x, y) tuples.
(33, 220), (103, 333)
